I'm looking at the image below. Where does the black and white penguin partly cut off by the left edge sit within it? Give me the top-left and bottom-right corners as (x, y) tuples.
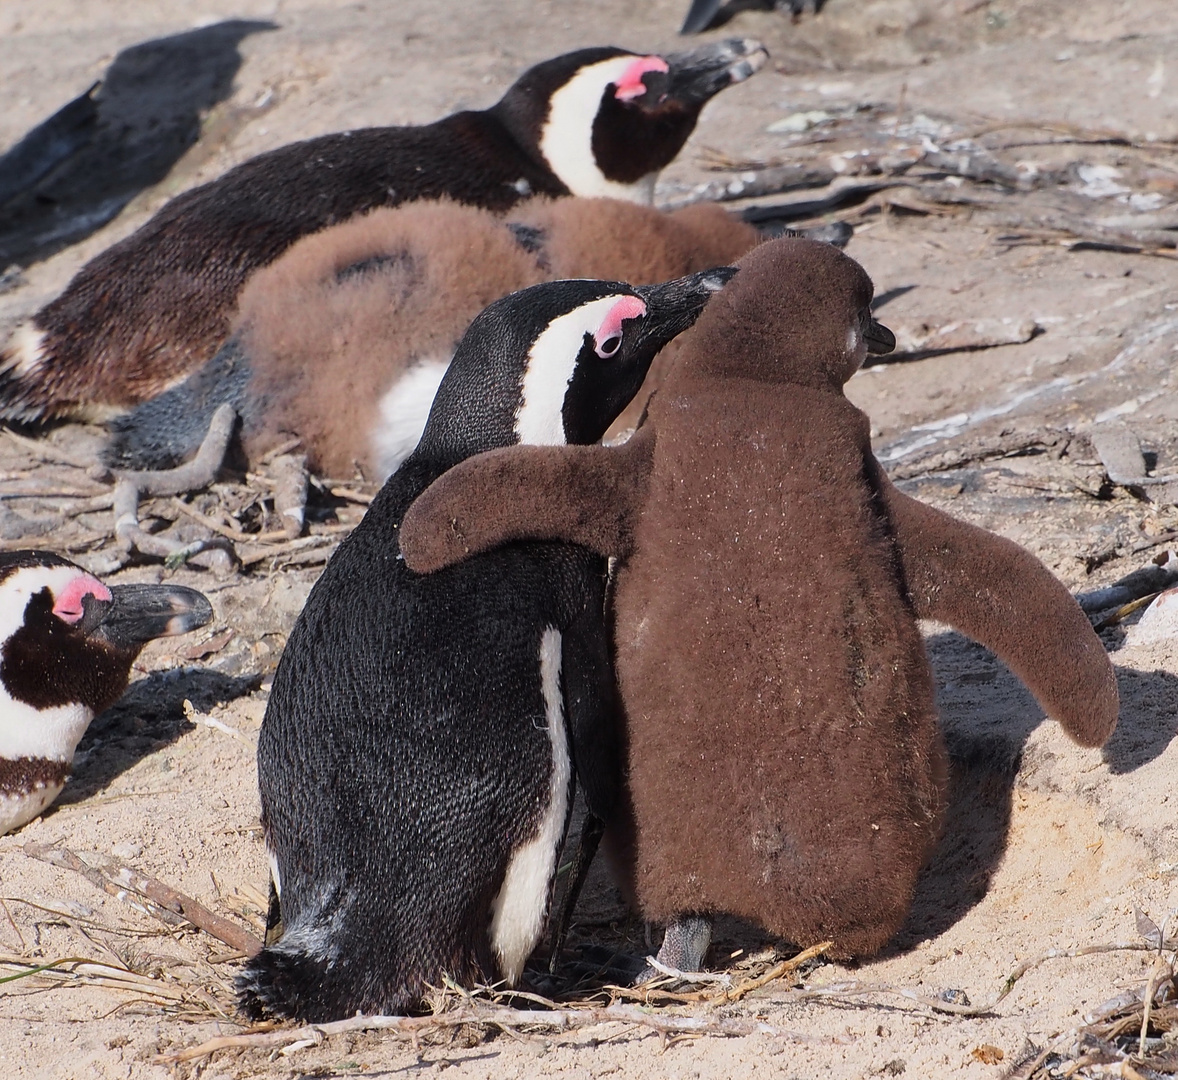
(0, 551), (213, 834)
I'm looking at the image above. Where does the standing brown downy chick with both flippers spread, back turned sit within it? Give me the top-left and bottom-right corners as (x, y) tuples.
(401, 239), (1118, 968)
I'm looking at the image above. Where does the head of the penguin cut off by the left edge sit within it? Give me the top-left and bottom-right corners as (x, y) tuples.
(0, 551), (212, 720)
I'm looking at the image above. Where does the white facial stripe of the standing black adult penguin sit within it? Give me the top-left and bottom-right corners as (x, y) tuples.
(515, 294), (623, 446)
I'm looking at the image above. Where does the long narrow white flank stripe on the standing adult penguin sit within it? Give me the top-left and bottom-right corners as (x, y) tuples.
(491, 627), (573, 986)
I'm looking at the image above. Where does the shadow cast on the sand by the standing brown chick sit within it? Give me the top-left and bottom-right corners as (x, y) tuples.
(882, 631), (1178, 956)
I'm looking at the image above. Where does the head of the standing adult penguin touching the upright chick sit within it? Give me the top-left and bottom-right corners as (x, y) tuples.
(415, 266), (736, 461)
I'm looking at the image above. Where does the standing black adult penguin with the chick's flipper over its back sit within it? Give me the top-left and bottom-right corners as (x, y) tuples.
(238, 267), (734, 1021)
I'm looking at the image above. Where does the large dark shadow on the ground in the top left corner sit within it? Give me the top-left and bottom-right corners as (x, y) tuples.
(0, 19), (277, 270)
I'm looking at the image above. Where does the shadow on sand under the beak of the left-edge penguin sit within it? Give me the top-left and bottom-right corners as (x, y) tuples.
(58, 668), (262, 804)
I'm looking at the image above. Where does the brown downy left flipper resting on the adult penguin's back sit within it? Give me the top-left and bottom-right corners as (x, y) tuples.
(399, 428), (655, 574)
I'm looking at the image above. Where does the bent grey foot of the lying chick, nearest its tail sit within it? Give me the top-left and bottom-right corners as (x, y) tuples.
(114, 405), (236, 574)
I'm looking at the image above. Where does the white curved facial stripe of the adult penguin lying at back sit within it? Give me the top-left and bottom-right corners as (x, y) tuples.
(540, 55), (657, 206)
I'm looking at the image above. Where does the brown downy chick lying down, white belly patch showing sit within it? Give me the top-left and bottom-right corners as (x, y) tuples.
(106, 199), (759, 479)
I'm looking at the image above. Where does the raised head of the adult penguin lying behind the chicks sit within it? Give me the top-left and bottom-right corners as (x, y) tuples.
(492, 39), (768, 204)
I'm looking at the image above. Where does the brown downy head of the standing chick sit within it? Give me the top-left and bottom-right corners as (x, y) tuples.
(683, 237), (895, 391)
